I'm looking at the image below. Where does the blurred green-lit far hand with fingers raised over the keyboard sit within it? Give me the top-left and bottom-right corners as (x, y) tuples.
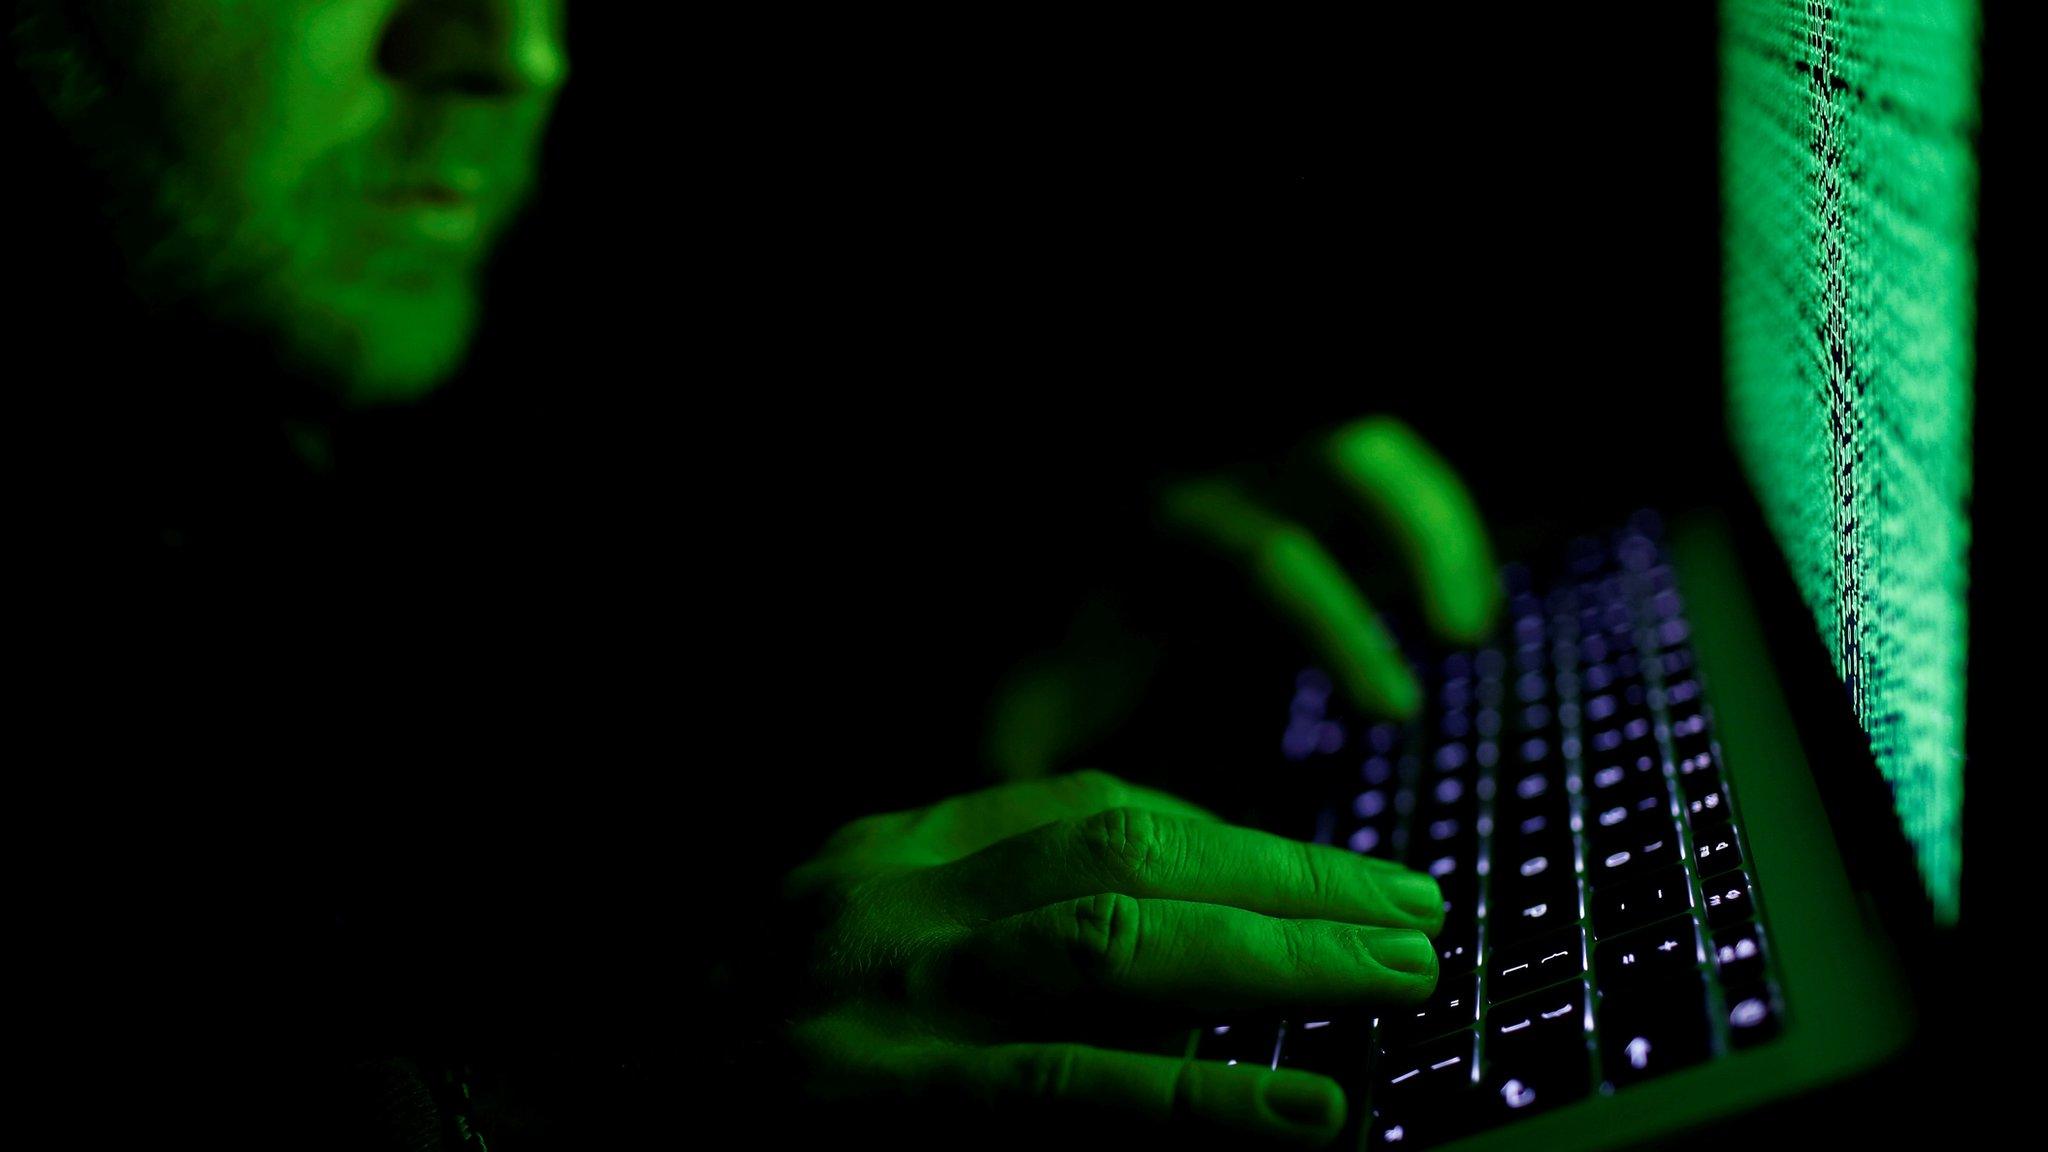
(987, 416), (1501, 779)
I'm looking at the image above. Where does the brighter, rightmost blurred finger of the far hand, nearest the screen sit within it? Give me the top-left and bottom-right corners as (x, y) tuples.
(1325, 416), (1501, 644)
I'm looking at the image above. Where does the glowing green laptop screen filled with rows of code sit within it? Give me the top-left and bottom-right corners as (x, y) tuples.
(1720, 0), (1978, 922)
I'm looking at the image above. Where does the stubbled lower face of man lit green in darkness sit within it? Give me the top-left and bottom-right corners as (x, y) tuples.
(39, 0), (567, 404)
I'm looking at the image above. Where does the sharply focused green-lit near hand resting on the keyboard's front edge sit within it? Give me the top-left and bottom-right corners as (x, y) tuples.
(788, 773), (1444, 1146)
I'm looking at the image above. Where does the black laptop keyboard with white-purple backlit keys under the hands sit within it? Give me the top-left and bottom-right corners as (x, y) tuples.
(1196, 517), (1784, 1148)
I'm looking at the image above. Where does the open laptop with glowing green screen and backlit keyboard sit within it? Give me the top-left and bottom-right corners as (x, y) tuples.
(1186, 2), (1978, 1148)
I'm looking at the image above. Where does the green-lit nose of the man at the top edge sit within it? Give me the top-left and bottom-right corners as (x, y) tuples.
(377, 0), (569, 98)
